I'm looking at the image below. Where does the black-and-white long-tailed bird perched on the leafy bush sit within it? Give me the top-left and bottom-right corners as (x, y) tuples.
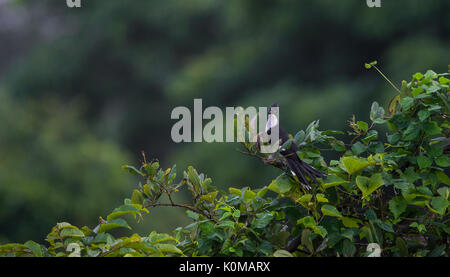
(265, 103), (327, 190)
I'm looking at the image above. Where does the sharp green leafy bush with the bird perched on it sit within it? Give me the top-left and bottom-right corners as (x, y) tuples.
(0, 66), (450, 257)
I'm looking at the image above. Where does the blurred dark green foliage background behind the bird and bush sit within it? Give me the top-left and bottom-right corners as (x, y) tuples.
(0, 0), (450, 243)
